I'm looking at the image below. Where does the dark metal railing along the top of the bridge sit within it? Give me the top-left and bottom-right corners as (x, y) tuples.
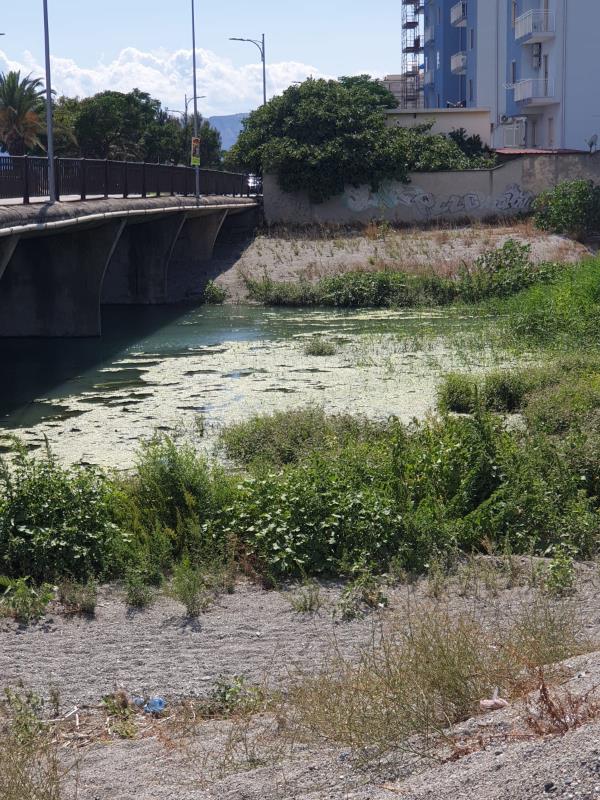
(0, 156), (262, 204)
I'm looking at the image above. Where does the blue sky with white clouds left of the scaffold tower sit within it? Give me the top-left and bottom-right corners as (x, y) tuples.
(0, 0), (401, 116)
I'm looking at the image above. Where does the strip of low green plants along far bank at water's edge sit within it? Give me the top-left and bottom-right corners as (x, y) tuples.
(246, 239), (565, 308)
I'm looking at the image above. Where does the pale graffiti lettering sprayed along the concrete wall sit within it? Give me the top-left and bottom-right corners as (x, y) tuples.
(344, 183), (533, 219)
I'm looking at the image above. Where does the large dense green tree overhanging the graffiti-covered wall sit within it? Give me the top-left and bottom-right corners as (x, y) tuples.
(226, 75), (492, 202)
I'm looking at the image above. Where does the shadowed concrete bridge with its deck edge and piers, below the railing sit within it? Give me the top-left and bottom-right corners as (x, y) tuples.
(0, 196), (258, 337)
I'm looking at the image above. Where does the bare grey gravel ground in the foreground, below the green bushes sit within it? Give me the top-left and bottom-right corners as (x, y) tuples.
(0, 565), (600, 800)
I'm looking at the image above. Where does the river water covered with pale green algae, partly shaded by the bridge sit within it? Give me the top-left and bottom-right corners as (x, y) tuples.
(0, 306), (506, 466)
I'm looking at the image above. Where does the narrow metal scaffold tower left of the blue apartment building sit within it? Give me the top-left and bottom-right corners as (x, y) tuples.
(400, 0), (425, 108)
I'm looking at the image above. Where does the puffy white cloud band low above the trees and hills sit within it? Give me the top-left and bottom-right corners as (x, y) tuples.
(0, 47), (320, 116)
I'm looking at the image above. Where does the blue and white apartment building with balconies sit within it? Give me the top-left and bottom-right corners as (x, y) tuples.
(414, 0), (600, 150)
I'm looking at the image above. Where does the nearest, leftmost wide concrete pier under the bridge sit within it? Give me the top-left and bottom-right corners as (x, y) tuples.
(0, 220), (125, 337)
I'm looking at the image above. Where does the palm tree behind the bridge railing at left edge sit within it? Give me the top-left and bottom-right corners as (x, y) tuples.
(0, 72), (44, 156)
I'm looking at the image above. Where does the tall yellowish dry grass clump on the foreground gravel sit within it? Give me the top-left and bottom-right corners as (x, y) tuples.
(290, 597), (584, 754)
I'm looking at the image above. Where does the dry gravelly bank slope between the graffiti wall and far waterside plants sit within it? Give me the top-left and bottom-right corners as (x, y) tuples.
(211, 222), (588, 303)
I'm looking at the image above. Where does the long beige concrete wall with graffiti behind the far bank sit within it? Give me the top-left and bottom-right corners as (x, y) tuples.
(264, 153), (600, 225)
